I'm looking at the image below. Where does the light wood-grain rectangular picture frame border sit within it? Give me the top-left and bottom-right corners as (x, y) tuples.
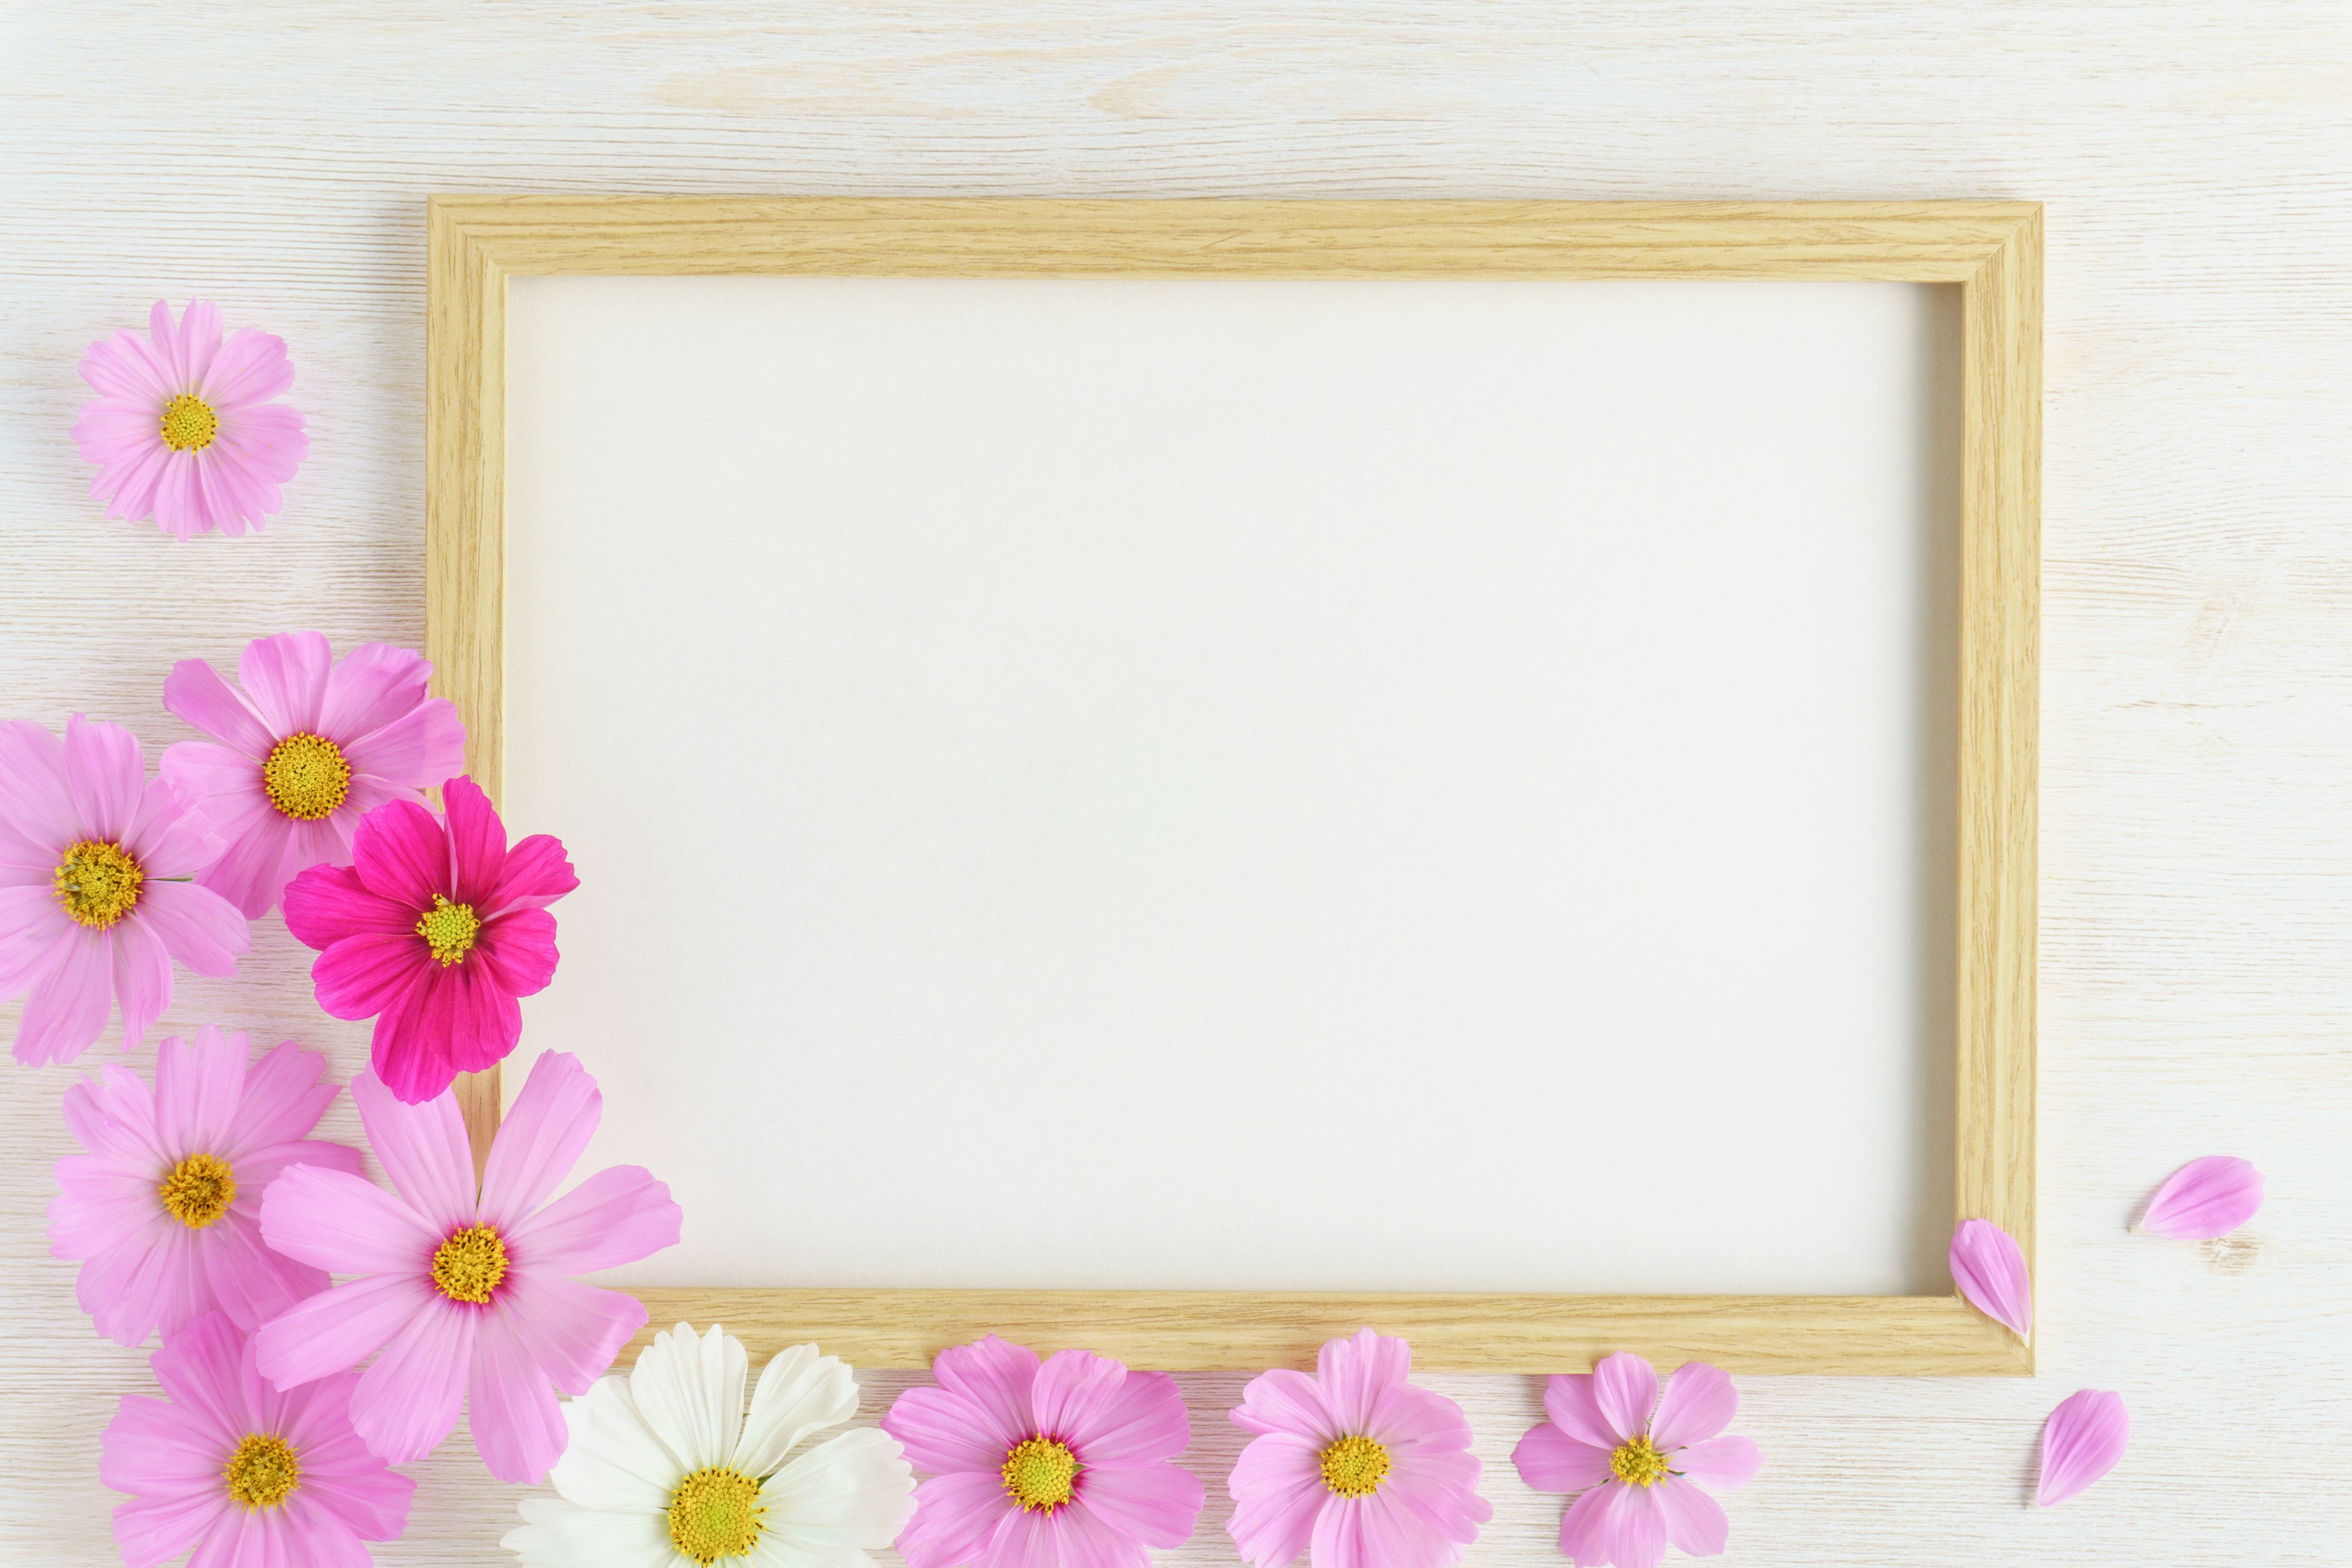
(426, 195), (2041, 1375)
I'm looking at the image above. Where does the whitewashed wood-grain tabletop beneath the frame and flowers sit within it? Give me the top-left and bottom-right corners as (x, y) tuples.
(0, 0), (2352, 1568)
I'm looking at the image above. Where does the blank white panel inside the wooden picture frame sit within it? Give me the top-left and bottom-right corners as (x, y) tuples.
(506, 277), (1959, 1293)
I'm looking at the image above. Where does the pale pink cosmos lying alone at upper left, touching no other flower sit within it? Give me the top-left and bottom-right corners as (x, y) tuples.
(73, 298), (311, 538)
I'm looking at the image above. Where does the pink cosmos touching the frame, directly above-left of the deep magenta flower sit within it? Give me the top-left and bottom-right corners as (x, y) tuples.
(162, 632), (466, 919)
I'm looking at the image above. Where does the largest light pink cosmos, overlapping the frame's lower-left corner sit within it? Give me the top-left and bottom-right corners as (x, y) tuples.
(254, 1051), (680, 1481)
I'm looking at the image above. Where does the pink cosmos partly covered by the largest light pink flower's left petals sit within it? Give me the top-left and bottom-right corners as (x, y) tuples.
(50, 1023), (360, 1344)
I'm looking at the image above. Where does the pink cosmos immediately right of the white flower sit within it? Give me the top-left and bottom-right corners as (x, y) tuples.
(882, 1335), (1207, 1568)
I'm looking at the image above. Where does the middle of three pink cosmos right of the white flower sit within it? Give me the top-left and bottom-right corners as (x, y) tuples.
(1226, 1329), (1493, 1568)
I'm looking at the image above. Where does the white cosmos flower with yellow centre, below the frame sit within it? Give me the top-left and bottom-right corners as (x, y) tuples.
(501, 1324), (915, 1568)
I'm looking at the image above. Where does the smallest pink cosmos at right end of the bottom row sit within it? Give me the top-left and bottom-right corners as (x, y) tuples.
(1510, 1352), (1762, 1568)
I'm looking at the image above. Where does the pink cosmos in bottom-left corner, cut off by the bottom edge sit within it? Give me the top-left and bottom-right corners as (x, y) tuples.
(99, 1312), (417, 1568)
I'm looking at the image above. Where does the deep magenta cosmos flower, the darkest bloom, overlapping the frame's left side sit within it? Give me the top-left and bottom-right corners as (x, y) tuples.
(285, 778), (581, 1105)
